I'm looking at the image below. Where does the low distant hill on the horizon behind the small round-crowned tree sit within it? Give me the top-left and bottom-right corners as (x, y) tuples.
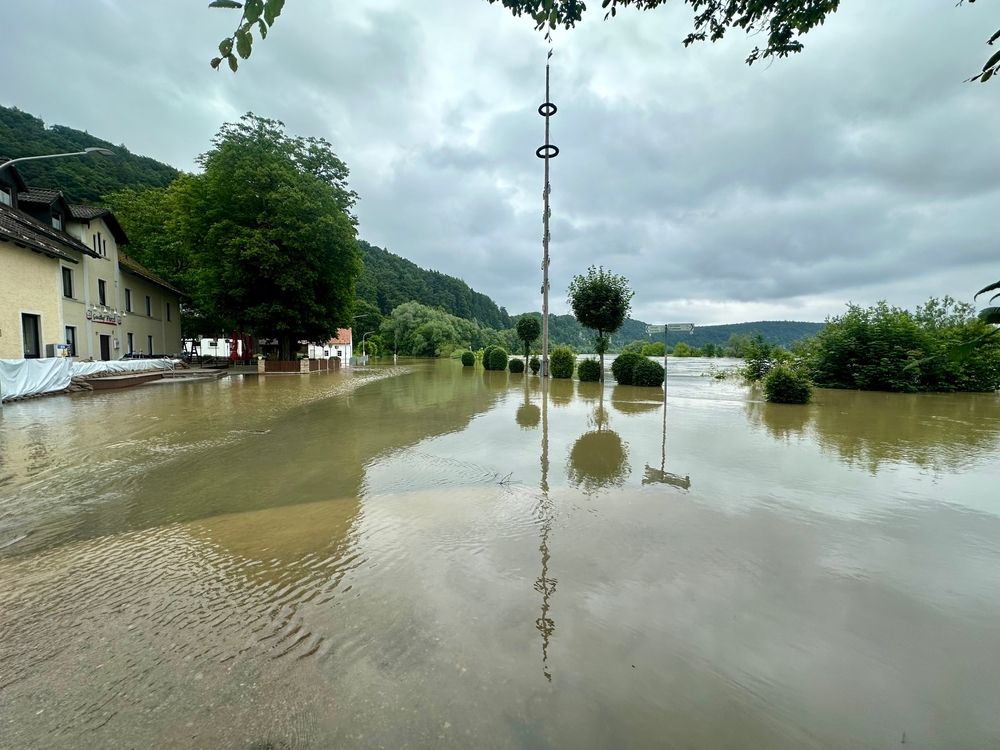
(513, 313), (824, 351)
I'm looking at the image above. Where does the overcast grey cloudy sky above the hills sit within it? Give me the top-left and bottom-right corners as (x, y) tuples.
(0, 0), (1000, 324)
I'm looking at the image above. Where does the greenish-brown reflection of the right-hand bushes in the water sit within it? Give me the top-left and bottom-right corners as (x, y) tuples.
(746, 390), (1000, 474)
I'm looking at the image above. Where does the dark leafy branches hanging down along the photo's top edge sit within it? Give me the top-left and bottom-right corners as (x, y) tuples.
(208, 0), (1000, 83)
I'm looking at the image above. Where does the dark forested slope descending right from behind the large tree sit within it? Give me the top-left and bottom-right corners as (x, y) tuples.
(357, 240), (511, 330)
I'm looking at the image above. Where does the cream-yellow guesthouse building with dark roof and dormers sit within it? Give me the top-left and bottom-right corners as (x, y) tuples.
(0, 166), (181, 360)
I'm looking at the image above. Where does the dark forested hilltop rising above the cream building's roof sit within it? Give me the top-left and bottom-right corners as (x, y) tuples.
(0, 107), (178, 203)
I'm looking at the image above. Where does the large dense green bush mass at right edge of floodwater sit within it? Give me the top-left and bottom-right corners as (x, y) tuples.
(808, 297), (1000, 392)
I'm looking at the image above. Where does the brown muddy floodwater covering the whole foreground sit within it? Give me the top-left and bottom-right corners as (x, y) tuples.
(0, 360), (1000, 749)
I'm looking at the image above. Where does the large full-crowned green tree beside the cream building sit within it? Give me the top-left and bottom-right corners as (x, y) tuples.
(192, 114), (361, 358)
